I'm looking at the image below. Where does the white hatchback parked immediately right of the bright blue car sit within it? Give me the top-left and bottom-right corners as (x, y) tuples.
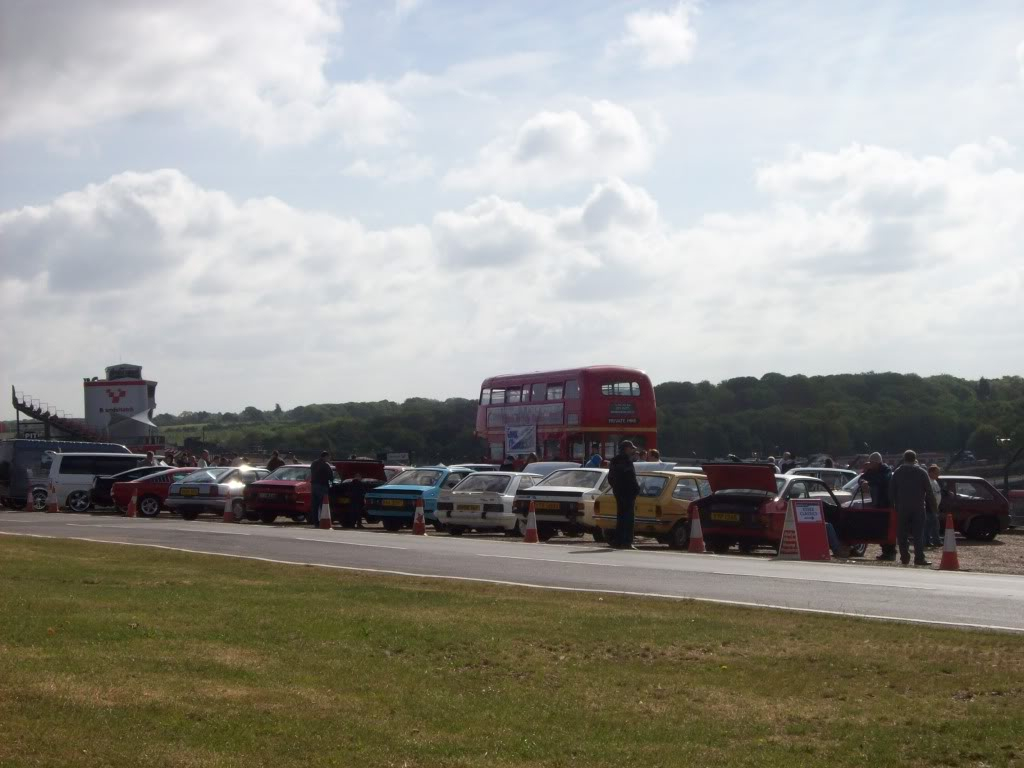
(437, 472), (543, 536)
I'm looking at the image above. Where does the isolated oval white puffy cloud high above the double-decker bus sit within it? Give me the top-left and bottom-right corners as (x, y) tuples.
(444, 100), (656, 189)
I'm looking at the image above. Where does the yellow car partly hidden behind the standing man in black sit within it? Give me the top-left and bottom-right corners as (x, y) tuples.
(594, 470), (711, 549)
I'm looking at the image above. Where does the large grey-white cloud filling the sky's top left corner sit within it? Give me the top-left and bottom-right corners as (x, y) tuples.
(0, 0), (411, 145)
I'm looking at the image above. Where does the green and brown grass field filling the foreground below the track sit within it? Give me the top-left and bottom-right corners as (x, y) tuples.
(0, 537), (1024, 768)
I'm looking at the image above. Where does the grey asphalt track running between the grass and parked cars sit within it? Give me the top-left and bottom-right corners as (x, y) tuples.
(0, 512), (1024, 632)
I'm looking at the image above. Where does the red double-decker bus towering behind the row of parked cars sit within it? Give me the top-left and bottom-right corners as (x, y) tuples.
(476, 366), (657, 462)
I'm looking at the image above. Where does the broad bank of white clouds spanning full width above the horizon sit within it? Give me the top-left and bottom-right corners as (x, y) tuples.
(0, 139), (1024, 410)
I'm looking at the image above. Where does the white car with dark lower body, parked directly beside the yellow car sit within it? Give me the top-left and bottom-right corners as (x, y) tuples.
(514, 466), (608, 542)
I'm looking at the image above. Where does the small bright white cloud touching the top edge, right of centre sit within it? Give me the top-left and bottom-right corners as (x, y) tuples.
(607, 0), (697, 70)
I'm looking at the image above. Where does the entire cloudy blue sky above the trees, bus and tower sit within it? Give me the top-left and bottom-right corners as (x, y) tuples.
(0, 0), (1024, 418)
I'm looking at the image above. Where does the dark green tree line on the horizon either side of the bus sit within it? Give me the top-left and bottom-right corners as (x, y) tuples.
(155, 373), (1024, 462)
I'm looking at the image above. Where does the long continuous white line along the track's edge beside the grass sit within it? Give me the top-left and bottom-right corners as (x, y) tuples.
(0, 530), (1024, 634)
